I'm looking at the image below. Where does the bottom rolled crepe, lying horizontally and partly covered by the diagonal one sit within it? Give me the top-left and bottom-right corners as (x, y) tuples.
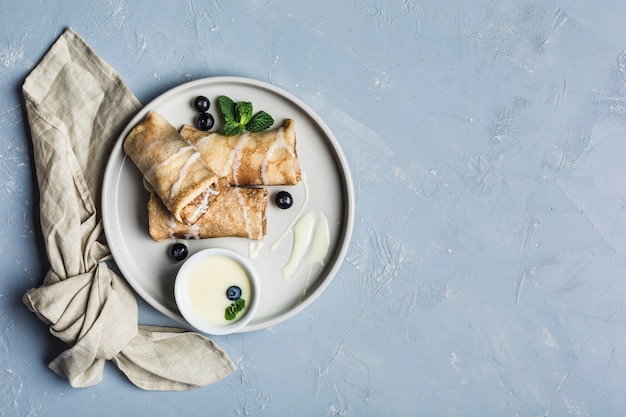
(148, 187), (269, 242)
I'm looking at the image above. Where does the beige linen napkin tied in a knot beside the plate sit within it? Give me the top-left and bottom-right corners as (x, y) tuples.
(23, 29), (235, 390)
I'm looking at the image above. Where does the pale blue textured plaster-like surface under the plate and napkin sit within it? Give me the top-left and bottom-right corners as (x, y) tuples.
(0, 0), (626, 417)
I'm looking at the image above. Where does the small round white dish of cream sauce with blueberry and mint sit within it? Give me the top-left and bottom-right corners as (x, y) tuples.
(174, 248), (260, 335)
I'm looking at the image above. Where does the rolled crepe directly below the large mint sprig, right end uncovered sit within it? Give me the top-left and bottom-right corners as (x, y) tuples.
(180, 119), (301, 186)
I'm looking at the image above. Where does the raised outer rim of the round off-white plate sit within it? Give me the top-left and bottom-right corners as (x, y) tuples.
(100, 76), (356, 333)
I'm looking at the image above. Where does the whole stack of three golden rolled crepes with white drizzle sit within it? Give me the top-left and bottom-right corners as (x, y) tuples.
(124, 111), (301, 241)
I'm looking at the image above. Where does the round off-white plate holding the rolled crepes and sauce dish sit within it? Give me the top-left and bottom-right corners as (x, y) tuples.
(102, 77), (354, 331)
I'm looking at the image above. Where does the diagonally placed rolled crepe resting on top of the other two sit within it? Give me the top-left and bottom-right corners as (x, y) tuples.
(124, 112), (219, 224)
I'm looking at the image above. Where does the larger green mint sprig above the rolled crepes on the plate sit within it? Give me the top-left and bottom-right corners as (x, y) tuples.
(217, 96), (274, 136)
